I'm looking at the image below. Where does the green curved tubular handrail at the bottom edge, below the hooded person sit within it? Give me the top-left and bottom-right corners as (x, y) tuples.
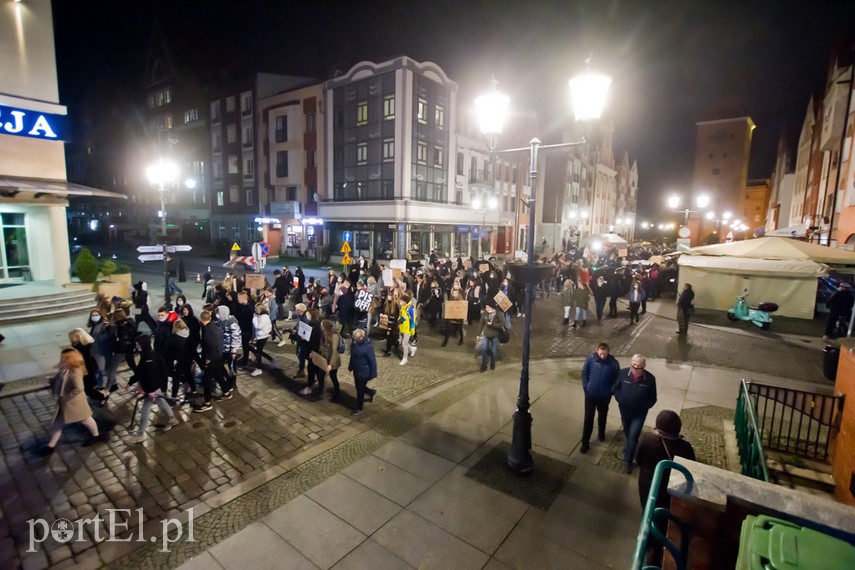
(632, 460), (695, 570)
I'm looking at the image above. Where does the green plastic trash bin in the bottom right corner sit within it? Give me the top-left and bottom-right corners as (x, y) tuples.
(736, 515), (855, 570)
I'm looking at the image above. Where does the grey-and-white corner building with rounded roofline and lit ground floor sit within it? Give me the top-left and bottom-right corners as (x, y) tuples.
(318, 57), (476, 260)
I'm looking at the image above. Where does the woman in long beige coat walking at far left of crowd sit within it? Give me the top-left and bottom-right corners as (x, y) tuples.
(39, 348), (103, 455)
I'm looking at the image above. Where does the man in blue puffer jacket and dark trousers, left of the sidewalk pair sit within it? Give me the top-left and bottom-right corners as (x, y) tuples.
(580, 342), (620, 453)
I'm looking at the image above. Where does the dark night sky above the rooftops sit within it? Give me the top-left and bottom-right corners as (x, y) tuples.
(53, 0), (855, 217)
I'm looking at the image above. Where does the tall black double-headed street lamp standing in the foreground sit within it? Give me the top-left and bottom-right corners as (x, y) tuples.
(477, 60), (612, 474)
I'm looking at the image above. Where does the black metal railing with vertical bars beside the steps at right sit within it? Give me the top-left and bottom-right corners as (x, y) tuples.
(743, 381), (844, 461)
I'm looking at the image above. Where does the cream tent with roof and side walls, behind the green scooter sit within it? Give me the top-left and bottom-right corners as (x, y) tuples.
(678, 233), (855, 319)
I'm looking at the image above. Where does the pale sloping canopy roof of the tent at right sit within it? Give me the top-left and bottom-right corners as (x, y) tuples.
(683, 237), (855, 265)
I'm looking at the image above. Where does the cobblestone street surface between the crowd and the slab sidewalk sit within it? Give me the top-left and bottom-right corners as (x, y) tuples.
(0, 295), (822, 568)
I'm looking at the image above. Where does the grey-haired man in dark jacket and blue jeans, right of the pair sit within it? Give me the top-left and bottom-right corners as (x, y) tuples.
(612, 354), (656, 473)
